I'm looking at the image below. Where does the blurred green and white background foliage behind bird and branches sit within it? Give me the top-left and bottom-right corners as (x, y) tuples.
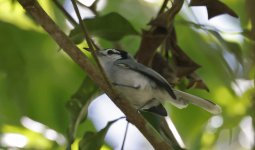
(0, 0), (255, 150)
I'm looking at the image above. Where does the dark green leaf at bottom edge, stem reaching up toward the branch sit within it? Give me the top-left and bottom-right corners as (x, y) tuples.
(79, 118), (122, 150)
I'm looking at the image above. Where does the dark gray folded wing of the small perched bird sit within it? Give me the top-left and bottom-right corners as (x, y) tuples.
(114, 59), (176, 99)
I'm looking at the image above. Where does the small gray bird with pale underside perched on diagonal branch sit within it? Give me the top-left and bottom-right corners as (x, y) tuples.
(97, 49), (221, 116)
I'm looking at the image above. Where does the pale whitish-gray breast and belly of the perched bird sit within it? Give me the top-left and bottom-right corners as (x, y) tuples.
(108, 63), (159, 109)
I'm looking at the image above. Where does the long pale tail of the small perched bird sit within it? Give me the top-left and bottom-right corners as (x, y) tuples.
(174, 90), (221, 114)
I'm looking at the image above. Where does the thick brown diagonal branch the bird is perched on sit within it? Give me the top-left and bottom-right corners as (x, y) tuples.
(18, 0), (173, 150)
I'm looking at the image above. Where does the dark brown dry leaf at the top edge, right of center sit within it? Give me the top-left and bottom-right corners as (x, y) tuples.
(189, 0), (238, 19)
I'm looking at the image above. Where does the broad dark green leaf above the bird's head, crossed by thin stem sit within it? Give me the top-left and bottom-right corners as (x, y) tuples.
(69, 13), (138, 44)
